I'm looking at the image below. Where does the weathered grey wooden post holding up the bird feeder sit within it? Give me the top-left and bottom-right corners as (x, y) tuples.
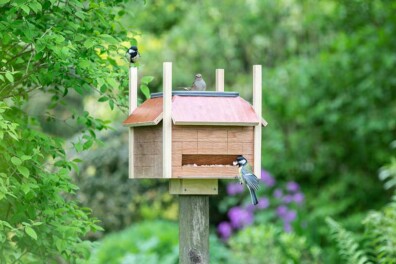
(179, 195), (209, 264)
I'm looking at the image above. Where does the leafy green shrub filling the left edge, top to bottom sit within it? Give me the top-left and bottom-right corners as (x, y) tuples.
(0, 0), (136, 263)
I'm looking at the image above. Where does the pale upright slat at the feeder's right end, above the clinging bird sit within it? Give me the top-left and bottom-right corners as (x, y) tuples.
(253, 65), (262, 178)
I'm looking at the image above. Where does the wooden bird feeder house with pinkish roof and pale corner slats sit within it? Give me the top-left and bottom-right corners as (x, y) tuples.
(123, 62), (266, 179)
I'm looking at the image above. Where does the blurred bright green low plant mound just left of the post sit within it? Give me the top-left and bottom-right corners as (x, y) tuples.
(90, 221), (179, 264)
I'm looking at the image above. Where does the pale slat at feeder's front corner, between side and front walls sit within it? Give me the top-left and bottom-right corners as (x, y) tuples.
(162, 62), (172, 178)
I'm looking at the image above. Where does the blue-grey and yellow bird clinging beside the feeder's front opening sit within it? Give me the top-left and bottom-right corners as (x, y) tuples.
(233, 155), (259, 205)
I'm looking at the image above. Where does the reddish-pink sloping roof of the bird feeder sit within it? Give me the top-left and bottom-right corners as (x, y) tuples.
(123, 91), (266, 127)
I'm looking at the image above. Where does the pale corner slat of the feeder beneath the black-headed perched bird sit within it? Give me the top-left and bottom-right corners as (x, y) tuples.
(129, 66), (138, 178)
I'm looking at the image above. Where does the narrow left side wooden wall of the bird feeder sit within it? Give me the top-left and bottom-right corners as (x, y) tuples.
(134, 123), (163, 179)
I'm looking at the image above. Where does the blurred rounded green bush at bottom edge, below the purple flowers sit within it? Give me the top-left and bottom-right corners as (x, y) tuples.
(229, 224), (322, 264)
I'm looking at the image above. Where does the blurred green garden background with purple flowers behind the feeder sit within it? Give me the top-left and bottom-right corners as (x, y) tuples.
(0, 0), (396, 264)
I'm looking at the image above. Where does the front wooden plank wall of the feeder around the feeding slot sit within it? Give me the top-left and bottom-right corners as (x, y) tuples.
(172, 126), (254, 178)
